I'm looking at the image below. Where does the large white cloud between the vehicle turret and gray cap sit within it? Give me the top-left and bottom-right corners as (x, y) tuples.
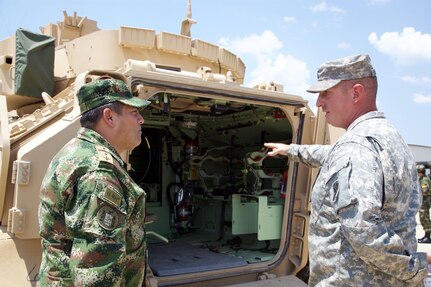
(219, 31), (315, 101)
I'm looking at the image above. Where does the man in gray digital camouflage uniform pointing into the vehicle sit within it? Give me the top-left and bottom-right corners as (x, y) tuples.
(265, 55), (427, 286)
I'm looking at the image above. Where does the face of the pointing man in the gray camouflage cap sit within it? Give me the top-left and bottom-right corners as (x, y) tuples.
(316, 83), (351, 129)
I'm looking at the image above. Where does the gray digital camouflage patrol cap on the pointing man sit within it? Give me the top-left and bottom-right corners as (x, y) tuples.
(307, 55), (376, 93)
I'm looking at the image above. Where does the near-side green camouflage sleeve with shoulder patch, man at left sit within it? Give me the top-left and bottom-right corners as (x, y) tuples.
(65, 171), (126, 286)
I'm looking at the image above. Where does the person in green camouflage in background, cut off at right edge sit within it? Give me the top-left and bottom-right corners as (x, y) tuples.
(416, 164), (431, 243)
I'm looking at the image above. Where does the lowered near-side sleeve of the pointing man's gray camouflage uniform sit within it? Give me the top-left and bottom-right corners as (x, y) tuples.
(327, 143), (426, 281)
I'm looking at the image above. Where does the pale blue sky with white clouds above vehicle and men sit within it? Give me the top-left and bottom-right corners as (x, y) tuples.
(0, 0), (431, 146)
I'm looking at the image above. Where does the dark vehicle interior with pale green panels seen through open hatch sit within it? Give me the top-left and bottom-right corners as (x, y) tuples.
(129, 92), (292, 276)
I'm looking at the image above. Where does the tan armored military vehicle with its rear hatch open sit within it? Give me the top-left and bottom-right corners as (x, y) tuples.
(0, 2), (340, 287)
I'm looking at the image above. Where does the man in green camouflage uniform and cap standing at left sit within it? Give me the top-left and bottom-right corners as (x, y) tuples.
(39, 79), (149, 286)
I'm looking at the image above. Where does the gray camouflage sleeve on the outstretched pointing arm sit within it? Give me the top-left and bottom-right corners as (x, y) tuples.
(287, 144), (332, 167)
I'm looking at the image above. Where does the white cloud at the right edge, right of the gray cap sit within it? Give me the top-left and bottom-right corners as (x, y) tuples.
(368, 27), (431, 64)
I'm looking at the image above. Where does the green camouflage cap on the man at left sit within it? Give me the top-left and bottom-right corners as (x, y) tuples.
(78, 79), (150, 114)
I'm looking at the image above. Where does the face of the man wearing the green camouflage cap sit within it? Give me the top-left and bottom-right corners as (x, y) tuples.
(115, 105), (144, 152)
